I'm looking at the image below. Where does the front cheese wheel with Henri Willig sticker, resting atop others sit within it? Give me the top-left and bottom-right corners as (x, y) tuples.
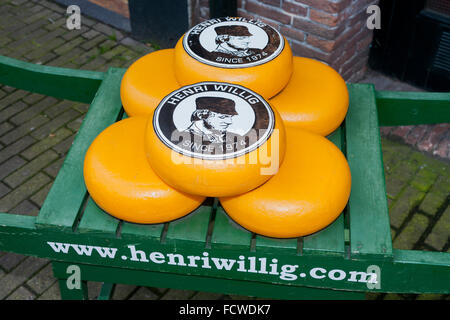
(145, 82), (285, 197)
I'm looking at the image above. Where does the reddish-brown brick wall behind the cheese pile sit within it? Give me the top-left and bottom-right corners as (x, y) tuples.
(192, 0), (378, 81)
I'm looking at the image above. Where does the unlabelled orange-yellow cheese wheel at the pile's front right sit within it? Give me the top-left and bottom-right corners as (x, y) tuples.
(220, 127), (351, 238)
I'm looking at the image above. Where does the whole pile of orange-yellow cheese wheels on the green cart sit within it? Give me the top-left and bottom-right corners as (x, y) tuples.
(84, 17), (351, 238)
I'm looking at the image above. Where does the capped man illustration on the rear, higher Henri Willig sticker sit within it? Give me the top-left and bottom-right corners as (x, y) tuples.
(213, 25), (261, 57)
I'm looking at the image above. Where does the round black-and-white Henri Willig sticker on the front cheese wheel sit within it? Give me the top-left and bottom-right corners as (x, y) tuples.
(153, 82), (275, 160)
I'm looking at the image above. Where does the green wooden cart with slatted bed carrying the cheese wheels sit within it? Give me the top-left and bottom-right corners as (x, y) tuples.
(0, 56), (450, 299)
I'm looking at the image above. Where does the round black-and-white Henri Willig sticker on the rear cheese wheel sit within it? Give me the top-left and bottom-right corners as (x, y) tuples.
(183, 17), (284, 68)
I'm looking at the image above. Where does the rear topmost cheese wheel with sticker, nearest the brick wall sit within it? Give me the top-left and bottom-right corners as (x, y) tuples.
(174, 17), (292, 99)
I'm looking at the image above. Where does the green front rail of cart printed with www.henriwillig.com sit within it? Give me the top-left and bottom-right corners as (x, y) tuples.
(0, 213), (450, 296)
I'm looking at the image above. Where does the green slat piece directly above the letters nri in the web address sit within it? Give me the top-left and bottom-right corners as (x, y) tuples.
(165, 205), (212, 246)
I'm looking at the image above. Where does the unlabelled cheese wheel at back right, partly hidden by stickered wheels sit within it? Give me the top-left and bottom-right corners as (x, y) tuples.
(270, 57), (349, 136)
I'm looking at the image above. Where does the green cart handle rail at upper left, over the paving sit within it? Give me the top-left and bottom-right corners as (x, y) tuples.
(0, 56), (105, 103)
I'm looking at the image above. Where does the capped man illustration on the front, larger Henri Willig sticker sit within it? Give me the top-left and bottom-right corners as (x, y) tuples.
(185, 97), (238, 143)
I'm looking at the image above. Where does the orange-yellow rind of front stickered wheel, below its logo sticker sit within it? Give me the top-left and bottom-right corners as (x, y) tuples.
(145, 99), (286, 197)
